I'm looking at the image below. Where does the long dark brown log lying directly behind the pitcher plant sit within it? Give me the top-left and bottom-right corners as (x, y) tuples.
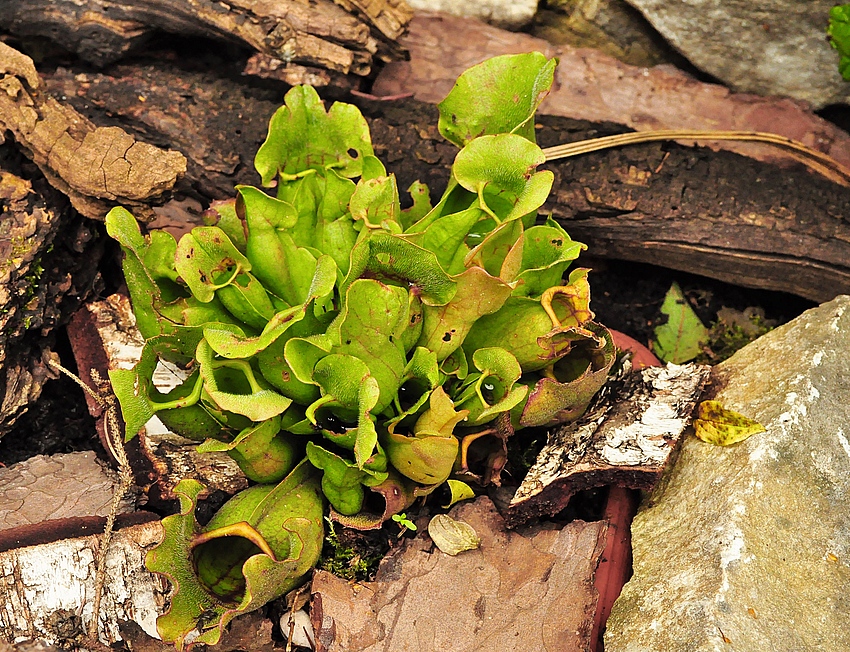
(47, 58), (850, 301)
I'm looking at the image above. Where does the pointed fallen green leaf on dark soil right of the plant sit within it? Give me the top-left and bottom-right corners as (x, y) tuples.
(652, 281), (709, 364)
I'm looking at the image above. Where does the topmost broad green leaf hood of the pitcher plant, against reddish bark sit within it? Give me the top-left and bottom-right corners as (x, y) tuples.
(438, 52), (558, 147)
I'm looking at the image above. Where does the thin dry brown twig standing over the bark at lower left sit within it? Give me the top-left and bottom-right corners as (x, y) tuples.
(48, 360), (133, 644)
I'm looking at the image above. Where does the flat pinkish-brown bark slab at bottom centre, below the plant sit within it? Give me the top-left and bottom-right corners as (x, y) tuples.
(311, 497), (607, 652)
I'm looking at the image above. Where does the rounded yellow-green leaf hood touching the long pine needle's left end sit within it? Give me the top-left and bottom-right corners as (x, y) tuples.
(452, 134), (555, 221)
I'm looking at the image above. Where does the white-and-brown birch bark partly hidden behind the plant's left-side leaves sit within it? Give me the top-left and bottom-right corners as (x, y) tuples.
(68, 295), (248, 505)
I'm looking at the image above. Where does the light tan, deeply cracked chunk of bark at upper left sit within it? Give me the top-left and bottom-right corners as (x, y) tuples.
(0, 42), (186, 219)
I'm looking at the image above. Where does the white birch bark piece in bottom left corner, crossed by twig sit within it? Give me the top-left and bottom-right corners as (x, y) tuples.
(0, 521), (164, 647)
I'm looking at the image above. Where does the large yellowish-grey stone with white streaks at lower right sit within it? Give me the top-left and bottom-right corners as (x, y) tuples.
(605, 296), (850, 652)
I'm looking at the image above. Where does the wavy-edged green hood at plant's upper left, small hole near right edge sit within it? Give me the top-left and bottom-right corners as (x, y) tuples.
(254, 86), (374, 187)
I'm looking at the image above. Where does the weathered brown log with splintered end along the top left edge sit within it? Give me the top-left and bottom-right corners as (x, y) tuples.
(0, 0), (412, 75)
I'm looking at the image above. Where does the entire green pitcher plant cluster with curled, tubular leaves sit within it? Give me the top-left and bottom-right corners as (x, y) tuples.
(107, 53), (614, 647)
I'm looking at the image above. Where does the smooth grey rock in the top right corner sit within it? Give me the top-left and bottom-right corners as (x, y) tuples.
(628, 0), (850, 109)
